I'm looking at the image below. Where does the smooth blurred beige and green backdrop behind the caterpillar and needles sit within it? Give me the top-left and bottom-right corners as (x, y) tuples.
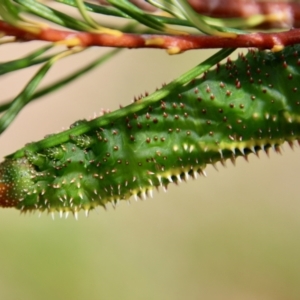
(0, 42), (300, 300)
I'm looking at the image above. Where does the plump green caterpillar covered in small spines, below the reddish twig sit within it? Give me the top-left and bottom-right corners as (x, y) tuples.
(0, 45), (300, 216)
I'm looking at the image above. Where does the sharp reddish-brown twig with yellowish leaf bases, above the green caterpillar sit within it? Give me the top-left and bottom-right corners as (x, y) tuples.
(0, 21), (300, 54)
